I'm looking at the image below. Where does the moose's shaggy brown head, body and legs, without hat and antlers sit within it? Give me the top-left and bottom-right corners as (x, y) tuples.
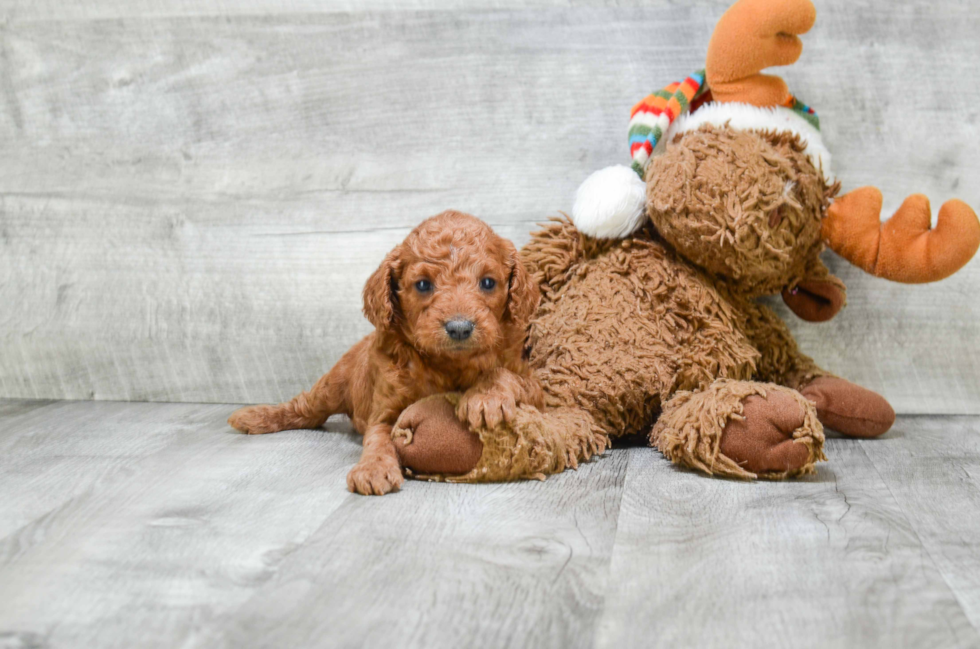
(392, 127), (894, 481)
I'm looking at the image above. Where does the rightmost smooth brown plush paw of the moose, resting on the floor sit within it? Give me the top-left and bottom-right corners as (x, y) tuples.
(800, 376), (895, 438)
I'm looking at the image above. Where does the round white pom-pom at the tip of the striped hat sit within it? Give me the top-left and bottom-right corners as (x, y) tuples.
(572, 165), (646, 239)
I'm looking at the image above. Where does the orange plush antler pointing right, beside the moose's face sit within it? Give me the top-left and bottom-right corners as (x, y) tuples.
(822, 187), (980, 284)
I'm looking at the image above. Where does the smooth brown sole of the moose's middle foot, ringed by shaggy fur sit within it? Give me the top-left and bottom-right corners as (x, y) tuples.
(720, 390), (811, 475)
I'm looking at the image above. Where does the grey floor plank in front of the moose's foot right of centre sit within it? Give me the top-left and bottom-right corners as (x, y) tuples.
(596, 436), (980, 648)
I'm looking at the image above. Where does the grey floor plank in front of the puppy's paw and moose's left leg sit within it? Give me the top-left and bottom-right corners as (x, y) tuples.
(209, 453), (626, 647)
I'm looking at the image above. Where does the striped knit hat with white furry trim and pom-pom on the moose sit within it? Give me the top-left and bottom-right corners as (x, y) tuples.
(572, 70), (831, 239)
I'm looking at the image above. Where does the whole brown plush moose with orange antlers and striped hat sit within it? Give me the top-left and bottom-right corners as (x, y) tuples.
(392, 0), (980, 482)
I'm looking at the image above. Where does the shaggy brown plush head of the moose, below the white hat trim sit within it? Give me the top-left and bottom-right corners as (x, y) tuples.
(647, 126), (840, 298)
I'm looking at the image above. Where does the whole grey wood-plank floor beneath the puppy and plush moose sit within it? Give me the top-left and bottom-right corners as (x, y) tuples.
(0, 401), (980, 649)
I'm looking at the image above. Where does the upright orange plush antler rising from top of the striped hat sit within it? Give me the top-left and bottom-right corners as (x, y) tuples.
(705, 0), (817, 106)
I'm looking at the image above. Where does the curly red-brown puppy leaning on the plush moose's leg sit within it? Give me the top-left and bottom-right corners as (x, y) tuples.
(228, 211), (542, 495)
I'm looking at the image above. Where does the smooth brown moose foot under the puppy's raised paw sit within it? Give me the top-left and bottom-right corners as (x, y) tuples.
(391, 396), (483, 475)
